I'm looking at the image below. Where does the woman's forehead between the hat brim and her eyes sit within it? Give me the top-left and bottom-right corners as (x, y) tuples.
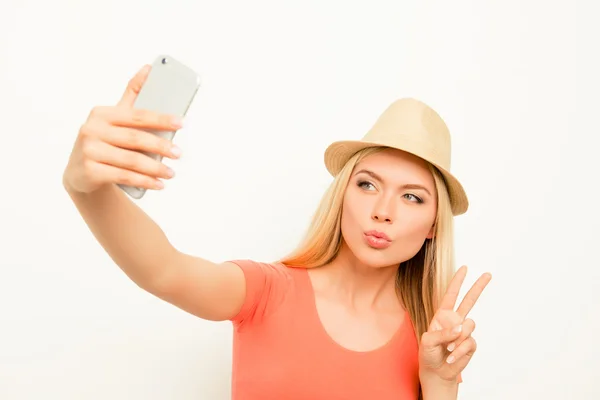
(354, 149), (435, 188)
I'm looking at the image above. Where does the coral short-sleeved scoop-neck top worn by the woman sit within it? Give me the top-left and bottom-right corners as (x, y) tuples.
(227, 260), (419, 400)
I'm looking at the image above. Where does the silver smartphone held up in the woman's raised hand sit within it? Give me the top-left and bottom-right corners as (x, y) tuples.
(118, 55), (201, 199)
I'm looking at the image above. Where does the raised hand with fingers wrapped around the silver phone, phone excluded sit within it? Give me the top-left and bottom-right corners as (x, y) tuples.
(63, 66), (181, 193)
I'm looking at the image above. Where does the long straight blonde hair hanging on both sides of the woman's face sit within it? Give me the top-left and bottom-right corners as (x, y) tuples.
(280, 147), (454, 342)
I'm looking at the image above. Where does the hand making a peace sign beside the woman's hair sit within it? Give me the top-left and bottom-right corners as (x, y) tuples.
(419, 266), (492, 382)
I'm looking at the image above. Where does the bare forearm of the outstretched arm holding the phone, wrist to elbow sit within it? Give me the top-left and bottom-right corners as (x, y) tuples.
(65, 181), (175, 291)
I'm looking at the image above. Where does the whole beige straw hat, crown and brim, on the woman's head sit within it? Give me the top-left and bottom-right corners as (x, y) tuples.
(325, 98), (469, 215)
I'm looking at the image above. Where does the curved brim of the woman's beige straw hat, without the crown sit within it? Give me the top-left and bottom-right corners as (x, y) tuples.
(324, 140), (469, 216)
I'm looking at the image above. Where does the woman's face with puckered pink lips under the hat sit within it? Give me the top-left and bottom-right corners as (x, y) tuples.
(342, 149), (437, 268)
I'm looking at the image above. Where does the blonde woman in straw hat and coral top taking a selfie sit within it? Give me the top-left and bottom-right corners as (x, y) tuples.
(63, 67), (491, 400)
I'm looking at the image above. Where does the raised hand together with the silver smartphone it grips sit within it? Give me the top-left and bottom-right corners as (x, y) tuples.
(63, 56), (200, 199)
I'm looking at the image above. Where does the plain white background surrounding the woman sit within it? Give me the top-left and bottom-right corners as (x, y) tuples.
(0, 0), (600, 400)
